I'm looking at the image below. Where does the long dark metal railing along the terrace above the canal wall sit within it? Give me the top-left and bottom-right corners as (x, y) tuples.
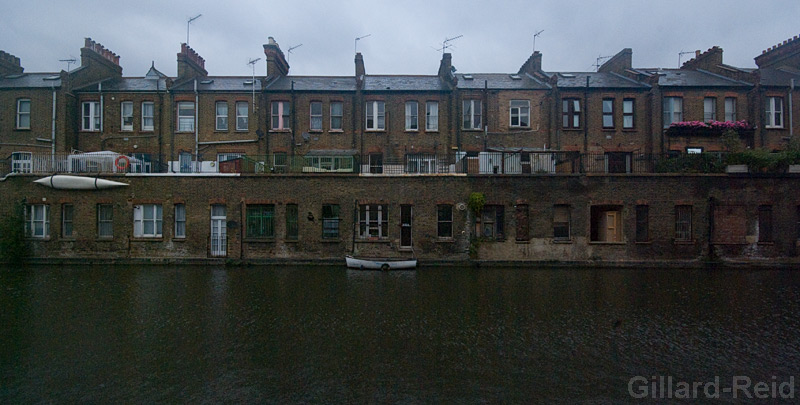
(0, 151), (788, 176)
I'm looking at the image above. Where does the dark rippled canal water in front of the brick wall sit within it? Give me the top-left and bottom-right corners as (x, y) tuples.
(0, 266), (800, 404)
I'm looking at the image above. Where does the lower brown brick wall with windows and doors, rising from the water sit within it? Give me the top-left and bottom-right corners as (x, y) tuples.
(0, 174), (800, 267)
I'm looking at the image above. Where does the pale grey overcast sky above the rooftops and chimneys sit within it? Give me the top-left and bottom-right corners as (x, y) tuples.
(0, 0), (800, 77)
